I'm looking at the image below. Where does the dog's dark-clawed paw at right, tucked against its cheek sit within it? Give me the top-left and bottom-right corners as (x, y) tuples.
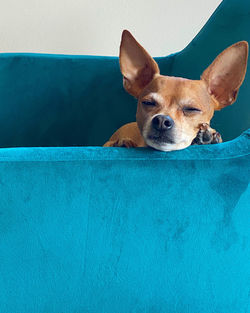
(192, 123), (222, 145)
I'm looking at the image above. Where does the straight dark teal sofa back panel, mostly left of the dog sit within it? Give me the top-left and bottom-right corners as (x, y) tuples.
(0, 54), (174, 147)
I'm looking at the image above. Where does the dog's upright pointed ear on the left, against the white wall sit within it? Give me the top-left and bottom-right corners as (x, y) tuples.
(119, 30), (160, 98)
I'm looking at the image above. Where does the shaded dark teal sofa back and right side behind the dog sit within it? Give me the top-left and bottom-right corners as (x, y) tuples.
(0, 0), (250, 147)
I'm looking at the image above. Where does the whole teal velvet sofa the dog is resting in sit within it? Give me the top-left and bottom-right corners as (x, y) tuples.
(0, 0), (250, 313)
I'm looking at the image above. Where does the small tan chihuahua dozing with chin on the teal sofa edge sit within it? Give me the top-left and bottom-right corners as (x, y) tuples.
(104, 30), (248, 151)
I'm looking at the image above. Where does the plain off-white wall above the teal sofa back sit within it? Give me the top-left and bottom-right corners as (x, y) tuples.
(0, 0), (221, 56)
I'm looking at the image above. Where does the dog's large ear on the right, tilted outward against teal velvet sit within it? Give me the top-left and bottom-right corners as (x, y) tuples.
(201, 41), (248, 110)
